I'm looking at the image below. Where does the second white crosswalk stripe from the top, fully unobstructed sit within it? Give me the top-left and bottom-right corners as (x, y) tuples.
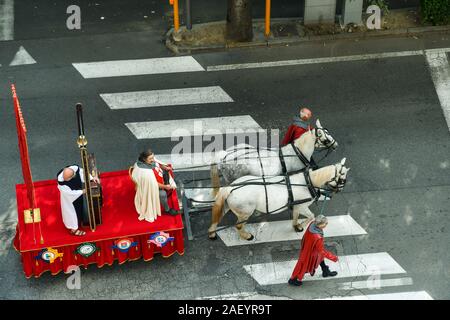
(100, 86), (233, 110)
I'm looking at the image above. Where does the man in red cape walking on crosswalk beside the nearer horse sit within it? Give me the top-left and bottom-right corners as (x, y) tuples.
(288, 215), (338, 286)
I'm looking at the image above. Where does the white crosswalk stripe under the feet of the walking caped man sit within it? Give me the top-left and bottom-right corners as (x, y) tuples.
(244, 252), (406, 285)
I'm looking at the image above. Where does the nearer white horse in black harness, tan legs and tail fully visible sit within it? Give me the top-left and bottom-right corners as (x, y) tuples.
(208, 158), (350, 241)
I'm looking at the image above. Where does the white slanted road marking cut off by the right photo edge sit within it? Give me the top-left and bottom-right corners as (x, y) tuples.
(425, 50), (450, 130)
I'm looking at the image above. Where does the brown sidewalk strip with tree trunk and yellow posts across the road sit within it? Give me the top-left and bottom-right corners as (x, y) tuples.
(166, 8), (450, 54)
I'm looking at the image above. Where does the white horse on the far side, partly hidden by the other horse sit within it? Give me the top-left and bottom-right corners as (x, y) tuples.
(210, 119), (338, 192)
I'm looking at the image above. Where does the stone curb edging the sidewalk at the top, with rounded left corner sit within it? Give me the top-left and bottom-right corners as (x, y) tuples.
(166, 25), (450, 55)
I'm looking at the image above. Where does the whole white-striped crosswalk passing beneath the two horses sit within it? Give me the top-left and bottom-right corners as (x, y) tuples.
(73, 52), (432, 300)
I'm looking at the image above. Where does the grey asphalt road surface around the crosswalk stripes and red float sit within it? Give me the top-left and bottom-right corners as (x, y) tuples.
(0, 1), (450, 299)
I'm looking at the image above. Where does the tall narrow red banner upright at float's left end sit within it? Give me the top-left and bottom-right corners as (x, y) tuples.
(11, 84), (36, 209)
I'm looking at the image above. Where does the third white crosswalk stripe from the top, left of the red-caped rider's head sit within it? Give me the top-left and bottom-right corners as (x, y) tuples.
(125, 115), (262, 139)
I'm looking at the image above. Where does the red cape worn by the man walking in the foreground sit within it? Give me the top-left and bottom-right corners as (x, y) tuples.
(291, 224), (337, 281)
